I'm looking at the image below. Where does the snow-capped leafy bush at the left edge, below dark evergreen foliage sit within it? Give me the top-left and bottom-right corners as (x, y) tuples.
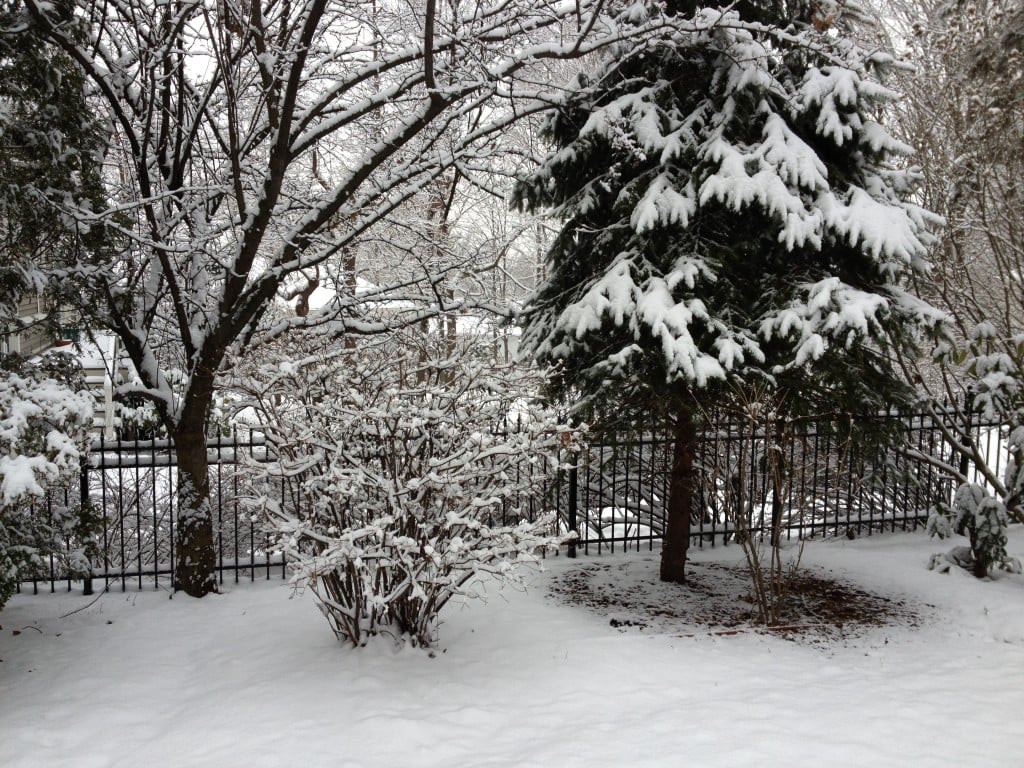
(0, 357), (93, 607)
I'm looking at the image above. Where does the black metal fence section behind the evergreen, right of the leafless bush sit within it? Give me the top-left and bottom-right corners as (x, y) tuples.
(556, 412), (1007, 554)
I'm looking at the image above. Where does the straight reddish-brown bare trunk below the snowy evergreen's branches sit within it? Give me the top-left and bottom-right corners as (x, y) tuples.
(660, 408), (697, 584)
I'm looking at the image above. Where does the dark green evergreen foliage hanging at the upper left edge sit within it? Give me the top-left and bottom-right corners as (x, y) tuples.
(0, 0), (114, 332)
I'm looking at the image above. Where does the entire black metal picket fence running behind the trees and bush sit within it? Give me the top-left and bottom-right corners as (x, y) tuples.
(23, 414), (1006, 592)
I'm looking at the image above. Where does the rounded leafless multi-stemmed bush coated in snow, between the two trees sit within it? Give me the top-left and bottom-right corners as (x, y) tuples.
(240, 333), (570, 646)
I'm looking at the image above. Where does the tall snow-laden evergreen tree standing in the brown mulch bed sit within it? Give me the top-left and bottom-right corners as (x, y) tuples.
(517, 0), (938, 582)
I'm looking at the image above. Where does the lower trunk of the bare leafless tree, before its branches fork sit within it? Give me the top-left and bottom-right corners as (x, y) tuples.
(174, 428), (217, 597)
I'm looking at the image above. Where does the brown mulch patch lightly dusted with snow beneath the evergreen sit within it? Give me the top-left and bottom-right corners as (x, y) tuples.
(549, 555), (924, 642)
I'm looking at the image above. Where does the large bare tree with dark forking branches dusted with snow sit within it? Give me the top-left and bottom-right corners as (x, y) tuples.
(26, 0), (679, 596)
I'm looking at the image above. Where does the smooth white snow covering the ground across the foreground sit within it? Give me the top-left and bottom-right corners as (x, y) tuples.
(0, 529), (1024, 768)
